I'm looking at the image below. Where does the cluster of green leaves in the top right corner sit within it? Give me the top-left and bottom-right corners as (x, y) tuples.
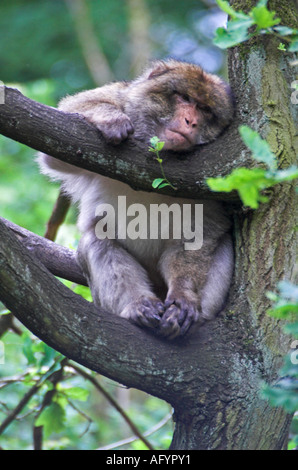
(214, 0), (298, 52)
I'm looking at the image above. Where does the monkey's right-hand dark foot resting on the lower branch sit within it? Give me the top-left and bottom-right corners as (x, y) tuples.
(159, 297), (204, 339)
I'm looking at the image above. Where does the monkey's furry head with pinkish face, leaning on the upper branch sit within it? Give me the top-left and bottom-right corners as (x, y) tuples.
(125, 60), (233, 152)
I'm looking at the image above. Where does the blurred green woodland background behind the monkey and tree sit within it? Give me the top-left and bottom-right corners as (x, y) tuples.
(0, 0), (226, 449)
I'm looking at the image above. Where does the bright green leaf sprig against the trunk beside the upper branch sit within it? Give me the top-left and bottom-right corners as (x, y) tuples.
(207, 126), (298, 209)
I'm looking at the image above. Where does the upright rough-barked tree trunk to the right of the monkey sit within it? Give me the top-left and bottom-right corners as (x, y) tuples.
(171, 0), (298, 450)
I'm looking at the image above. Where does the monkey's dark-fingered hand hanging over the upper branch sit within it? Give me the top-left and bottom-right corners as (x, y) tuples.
(85, 111), (134, 144)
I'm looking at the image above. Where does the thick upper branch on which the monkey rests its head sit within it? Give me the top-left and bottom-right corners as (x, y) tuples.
(0, 87), (242, 200)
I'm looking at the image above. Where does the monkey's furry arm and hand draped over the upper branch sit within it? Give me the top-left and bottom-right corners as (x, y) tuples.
(58, 82), (134, 144)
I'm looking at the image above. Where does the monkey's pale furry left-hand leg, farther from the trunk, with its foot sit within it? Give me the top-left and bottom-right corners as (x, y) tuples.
(78, 228), (164, 328)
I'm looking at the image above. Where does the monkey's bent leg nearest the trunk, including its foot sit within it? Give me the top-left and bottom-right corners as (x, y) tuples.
(160, 235), (233, 339)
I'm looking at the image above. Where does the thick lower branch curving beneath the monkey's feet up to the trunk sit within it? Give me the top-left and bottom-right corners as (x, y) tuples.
(0, 220), (208, 410)
